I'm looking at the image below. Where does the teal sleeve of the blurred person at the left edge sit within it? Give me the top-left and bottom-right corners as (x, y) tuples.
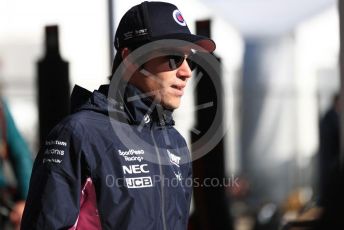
(3, 102), (32, 199)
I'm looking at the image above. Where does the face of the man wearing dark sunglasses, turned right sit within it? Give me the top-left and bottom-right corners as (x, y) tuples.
(130, 49), (192, 110)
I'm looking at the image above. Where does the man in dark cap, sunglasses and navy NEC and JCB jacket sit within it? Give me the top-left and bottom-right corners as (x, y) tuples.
(22, 2), (215, 230)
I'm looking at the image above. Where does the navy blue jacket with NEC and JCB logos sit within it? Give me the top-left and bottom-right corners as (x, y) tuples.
(21, 85), (191, 230)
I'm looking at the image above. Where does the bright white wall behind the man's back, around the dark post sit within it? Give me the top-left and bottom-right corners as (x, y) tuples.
(0, 0), (110, 152)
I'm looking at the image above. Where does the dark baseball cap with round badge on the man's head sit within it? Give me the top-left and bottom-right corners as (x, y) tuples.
(114, 1), (216, 52)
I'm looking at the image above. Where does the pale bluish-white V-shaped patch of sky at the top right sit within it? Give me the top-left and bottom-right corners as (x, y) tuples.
(201, 0), (337, 37)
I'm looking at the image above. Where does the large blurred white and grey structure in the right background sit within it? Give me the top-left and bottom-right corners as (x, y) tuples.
(242, 5), (339, 201)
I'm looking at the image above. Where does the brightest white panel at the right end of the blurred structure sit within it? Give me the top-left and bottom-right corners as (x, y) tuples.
(295, 6), (339, 162)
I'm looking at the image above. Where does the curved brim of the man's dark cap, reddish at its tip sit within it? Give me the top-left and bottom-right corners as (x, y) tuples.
(153, 33), (216, 53)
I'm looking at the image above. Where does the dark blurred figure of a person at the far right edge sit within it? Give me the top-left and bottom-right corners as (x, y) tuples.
(316, 94), (344, 229)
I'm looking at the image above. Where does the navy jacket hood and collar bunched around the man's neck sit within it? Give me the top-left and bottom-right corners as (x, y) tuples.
(71, 84), (174, 126)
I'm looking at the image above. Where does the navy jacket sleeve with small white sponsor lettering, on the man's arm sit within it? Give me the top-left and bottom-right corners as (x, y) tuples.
(21, 123), (83, 230)
